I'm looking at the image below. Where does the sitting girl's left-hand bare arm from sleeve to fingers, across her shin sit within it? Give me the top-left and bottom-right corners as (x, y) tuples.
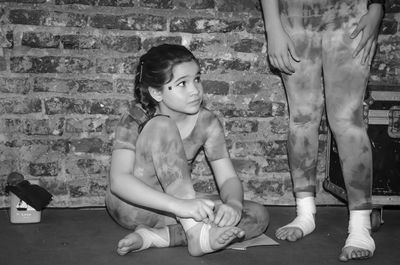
(110, 149), (214, 222)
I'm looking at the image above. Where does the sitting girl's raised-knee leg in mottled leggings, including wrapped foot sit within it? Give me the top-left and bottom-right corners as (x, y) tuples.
(142, 117), (244, 256)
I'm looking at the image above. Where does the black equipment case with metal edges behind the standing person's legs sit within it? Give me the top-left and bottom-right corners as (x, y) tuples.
(324, 86), (400, 231)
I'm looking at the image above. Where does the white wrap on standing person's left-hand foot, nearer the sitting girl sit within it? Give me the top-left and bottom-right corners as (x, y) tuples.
(282, 197), (316, 236)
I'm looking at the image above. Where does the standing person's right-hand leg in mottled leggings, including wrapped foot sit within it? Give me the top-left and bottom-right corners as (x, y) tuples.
(323, 1), (375, 261)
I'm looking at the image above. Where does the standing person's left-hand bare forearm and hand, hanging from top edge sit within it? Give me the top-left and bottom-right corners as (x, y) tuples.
(261, 0), (300, 74)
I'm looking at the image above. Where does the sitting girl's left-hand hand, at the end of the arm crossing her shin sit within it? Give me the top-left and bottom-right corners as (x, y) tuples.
(174, 199), (214, 223)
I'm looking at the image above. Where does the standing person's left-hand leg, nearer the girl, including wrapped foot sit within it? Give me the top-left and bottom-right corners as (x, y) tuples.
(276, 25), (324, 241)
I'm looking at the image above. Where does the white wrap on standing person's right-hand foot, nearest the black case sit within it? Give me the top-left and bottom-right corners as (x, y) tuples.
(343, 210), (375, 256)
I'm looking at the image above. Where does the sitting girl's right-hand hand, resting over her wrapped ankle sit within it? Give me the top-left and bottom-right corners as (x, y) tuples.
(214, 203), (242, 227)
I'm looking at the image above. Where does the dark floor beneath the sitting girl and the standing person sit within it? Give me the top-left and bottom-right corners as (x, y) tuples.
(0, 207), (400, 265)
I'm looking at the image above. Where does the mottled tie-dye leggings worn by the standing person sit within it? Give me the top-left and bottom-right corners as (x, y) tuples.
(280, 0), (372, 210)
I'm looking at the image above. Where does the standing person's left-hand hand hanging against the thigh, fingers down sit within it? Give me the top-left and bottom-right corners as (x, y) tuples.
(267, 27), (300, 75)
